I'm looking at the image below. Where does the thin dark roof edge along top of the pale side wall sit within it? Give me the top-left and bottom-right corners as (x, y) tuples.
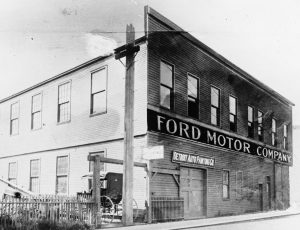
(0, 53), (114, 104)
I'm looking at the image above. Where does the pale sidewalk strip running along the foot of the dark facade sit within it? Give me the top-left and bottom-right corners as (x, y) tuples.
(98, 208), (300, 230)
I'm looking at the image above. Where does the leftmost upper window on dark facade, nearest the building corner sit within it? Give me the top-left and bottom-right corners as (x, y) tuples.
(160, 61), (174, 110)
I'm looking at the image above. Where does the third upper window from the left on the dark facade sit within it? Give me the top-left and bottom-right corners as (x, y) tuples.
(210, 87), (220, 125)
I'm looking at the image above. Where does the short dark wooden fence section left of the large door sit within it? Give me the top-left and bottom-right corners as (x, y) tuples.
(151, 197), (184, 222)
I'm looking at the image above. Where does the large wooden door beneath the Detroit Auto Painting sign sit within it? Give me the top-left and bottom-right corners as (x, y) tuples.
(180, 168), (205, 219)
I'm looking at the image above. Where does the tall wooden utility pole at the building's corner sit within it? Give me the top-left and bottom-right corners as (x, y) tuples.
(122, 24), (135, 225)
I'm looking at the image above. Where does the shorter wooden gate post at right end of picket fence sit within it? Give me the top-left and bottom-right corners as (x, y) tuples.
(93, 155), (101, 228)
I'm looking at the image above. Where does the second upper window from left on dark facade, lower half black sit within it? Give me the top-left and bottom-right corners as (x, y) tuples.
(187, 75), (199, 119)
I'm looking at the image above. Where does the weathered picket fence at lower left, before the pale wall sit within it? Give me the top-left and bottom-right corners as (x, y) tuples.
(0, 196), (94, 227)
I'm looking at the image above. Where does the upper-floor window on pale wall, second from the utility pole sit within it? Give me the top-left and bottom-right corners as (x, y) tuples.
(57, 82), (71, 123)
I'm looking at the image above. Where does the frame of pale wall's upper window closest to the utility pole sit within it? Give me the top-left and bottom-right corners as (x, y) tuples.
(90, 65), (108, 117)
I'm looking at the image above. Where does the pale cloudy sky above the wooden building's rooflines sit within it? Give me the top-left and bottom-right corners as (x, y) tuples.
(0, 0), (300, 201)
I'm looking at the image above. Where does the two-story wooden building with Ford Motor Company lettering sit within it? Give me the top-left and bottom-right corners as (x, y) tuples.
(0, 7), (293, 219)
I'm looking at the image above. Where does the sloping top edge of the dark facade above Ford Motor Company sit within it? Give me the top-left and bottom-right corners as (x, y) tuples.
(145, 6), (295, 106)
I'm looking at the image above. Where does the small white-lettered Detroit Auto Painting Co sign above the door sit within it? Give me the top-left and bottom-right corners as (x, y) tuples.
(172, 151), (215, 167)
